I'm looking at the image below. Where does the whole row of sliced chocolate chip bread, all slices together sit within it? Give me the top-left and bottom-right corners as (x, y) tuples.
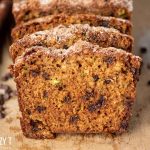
(10, 0), (142, 139)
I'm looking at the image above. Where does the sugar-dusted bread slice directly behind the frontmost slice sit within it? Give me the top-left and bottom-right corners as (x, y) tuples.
(10, 24), (133, 61)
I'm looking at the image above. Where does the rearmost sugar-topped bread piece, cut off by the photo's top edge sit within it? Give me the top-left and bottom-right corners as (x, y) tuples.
(13, 0), (133, 24)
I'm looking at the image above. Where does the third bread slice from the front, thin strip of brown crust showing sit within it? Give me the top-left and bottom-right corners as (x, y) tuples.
(12, 14), (132, 41)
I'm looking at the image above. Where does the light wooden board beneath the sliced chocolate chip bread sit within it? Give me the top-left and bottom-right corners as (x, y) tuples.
(0, 0), (150, 150)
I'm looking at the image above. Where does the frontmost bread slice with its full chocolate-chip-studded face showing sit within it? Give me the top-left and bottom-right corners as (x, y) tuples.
(11, 41), (141, 139)
